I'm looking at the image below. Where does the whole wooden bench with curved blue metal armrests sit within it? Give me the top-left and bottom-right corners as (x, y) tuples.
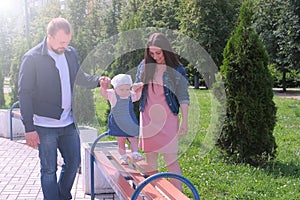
(90, 133), (200, 200)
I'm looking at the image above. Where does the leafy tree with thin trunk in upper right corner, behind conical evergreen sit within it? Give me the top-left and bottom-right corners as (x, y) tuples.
(255, 0), (300, 91)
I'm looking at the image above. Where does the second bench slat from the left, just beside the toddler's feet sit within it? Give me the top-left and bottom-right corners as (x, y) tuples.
(109, 150), (165, 199)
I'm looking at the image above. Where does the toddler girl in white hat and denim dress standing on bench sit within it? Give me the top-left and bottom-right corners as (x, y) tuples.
(100, 74), (144, 165)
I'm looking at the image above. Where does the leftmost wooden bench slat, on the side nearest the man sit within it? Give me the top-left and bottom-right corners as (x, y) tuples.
(94, 151), (142, 200)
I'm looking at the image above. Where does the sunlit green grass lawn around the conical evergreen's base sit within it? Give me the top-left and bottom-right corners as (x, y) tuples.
(96, 89), (300, 200)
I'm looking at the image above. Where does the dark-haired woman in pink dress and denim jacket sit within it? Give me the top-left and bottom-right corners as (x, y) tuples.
(136, 33), (189, 190)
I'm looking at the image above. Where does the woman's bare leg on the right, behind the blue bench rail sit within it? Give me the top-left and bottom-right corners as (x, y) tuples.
(163, 153), (182, 191)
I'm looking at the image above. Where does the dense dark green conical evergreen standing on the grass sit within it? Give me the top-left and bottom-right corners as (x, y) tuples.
(217, 1), (276, 166)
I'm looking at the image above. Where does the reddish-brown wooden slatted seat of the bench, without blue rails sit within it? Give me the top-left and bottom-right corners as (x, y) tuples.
(95, 150), (193, 200)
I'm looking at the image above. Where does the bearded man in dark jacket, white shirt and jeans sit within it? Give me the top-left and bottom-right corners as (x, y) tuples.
(18, 18), (100, 200)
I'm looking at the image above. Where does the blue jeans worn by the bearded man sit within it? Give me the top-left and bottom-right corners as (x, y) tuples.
(36, 124), (80, 200)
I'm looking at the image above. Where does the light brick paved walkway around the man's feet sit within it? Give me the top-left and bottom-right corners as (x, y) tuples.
(0, 137), (113, 200)
